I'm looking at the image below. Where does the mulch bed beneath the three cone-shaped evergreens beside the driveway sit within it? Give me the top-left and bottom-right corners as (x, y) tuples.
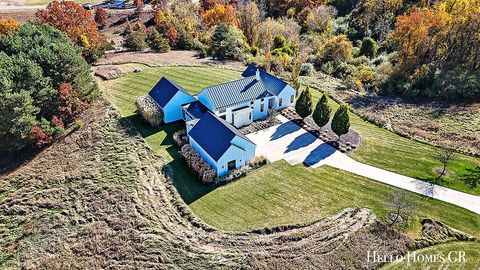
(280, 108), (361, 153)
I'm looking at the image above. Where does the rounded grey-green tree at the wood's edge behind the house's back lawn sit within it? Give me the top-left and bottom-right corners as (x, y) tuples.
(211, 23), (245, 60)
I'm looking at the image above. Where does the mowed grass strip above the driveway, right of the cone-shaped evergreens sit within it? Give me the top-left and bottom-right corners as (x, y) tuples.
(304, 86), (480, 195)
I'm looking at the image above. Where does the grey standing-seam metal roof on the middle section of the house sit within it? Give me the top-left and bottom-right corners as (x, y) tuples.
(202, 74), (272, 110)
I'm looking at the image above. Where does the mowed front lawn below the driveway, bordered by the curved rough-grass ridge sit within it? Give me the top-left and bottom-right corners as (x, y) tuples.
(190, 160), (480, 237)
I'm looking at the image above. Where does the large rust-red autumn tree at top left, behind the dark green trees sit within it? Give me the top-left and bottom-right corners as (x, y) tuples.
(35, 1), (105, 62)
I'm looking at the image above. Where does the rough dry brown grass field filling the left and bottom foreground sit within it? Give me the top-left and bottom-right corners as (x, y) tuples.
(0, 101), (412, 269)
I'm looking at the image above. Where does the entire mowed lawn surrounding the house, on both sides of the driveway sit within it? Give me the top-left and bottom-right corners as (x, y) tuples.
(102, 65), (480, 236)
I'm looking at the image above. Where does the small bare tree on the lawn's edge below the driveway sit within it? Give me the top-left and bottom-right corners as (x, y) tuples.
(385, 189), (418, 227)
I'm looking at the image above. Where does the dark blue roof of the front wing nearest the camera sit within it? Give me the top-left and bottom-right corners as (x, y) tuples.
(188, 111), (254, 161)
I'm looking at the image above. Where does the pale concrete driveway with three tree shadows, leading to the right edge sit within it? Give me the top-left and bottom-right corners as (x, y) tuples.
(247, 115), (480, 214)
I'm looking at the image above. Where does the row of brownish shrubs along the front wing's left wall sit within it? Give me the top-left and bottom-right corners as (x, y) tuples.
(180, 144), (217, 183)
